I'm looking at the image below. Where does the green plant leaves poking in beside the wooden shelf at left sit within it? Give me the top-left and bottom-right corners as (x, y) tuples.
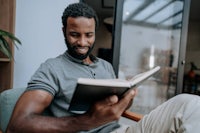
(0, 29), (21, 59)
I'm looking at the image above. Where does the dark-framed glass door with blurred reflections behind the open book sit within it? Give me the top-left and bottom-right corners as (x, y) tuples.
(113, 0), (189, 114)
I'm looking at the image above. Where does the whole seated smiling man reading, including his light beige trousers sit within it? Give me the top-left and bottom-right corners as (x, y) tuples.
(7, 3), (200, 133)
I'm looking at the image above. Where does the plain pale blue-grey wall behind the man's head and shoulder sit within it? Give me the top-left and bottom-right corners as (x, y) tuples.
(13, 0), (78, 87)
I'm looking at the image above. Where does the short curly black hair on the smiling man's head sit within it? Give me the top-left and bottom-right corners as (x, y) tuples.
(62, 2), (99, 29)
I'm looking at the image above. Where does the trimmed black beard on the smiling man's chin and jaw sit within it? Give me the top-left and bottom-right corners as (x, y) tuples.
(65, 38), (94, 60)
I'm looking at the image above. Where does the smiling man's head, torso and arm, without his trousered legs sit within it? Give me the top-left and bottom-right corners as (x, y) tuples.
(8, 3), (134, 133)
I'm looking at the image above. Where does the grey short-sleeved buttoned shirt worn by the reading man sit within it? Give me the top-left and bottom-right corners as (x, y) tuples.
(27, 52), (119, 132)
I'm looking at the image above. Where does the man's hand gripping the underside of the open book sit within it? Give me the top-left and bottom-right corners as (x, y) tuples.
(85, 89), (136, 128)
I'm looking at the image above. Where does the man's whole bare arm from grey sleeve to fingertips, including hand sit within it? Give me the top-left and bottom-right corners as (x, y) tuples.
(7, 90), (134, 133)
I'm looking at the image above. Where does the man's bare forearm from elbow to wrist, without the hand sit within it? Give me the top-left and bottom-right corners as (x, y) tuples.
(7, 115), (94, 133)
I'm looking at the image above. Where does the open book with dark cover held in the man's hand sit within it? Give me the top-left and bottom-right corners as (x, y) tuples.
(68, 66), (160, 114)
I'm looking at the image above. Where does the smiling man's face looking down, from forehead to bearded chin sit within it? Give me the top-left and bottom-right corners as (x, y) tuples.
(63, 17), (95, 60)
